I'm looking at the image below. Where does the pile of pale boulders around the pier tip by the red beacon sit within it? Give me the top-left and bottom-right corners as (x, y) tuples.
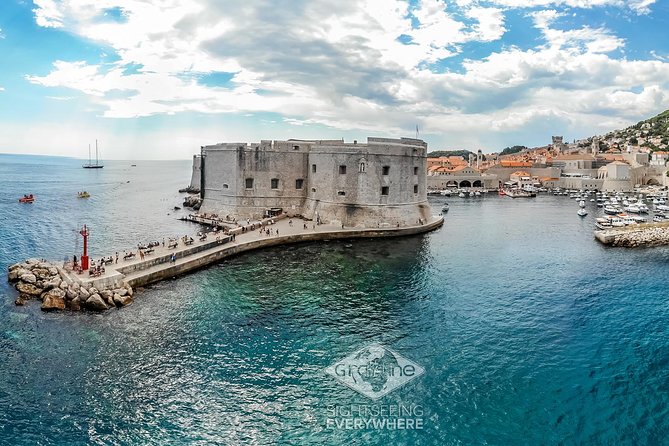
(7, 259), (133, 311)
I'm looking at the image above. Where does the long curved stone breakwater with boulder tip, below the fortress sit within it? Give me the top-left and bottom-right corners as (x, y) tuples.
(8, 214), (444, 311)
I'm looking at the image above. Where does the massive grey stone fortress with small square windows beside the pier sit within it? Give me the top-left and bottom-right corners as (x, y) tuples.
(191, 137), (431, 228)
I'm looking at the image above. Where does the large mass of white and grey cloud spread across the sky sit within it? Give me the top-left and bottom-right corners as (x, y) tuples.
(26, 0), (669, 152)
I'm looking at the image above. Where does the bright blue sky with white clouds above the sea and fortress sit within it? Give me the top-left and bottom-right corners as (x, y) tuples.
(0, 0), (669, 159)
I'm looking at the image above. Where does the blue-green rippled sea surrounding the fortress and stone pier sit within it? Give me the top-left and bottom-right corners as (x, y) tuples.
(0, 155), (669, 445)
